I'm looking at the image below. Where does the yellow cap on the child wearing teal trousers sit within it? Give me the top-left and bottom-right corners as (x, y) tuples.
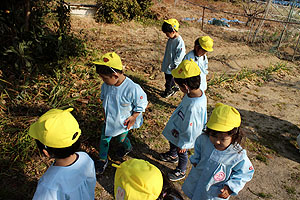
(93, 52), (123, 70)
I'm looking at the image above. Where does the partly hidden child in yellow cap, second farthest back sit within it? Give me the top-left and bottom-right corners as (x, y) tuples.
(184, 36), (214, 92)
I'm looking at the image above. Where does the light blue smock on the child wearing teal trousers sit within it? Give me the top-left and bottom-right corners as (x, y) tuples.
(100, 77), (148, 137)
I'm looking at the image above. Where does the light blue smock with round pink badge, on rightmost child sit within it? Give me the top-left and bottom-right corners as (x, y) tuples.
(182, 134), (254, 200)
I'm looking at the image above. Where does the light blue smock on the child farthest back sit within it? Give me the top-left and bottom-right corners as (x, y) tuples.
(161, 35), (185, 74)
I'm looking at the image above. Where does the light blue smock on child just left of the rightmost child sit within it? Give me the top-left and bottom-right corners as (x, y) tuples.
(162, 93), (207, 149)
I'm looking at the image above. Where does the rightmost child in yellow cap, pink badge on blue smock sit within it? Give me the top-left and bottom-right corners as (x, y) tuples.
(182, 103), (254, 199)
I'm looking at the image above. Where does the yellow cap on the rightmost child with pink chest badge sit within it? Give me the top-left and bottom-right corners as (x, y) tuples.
(206, 103), (241, 132)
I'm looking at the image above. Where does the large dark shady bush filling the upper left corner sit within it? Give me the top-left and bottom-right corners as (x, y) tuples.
(0, 0), (84, 79)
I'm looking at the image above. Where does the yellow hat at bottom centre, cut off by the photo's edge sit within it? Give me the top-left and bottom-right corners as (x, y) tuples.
(113, 159), (163, 200)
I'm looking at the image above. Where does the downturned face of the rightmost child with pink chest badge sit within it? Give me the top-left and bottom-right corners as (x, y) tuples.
(209, 133), (232, 151)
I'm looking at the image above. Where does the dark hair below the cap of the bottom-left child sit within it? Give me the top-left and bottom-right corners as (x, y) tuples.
(35, 139), (80, 158)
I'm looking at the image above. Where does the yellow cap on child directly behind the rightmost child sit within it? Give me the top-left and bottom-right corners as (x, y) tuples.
(171, 59), (201, 78)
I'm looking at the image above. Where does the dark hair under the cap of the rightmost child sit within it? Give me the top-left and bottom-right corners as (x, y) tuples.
(204, 127), (244, 146)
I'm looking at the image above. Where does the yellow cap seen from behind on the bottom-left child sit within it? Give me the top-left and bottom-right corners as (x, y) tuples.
(29, 108), (81, 148)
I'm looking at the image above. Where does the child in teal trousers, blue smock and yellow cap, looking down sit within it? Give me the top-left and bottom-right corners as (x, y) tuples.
(94, 52), (148, 174)
